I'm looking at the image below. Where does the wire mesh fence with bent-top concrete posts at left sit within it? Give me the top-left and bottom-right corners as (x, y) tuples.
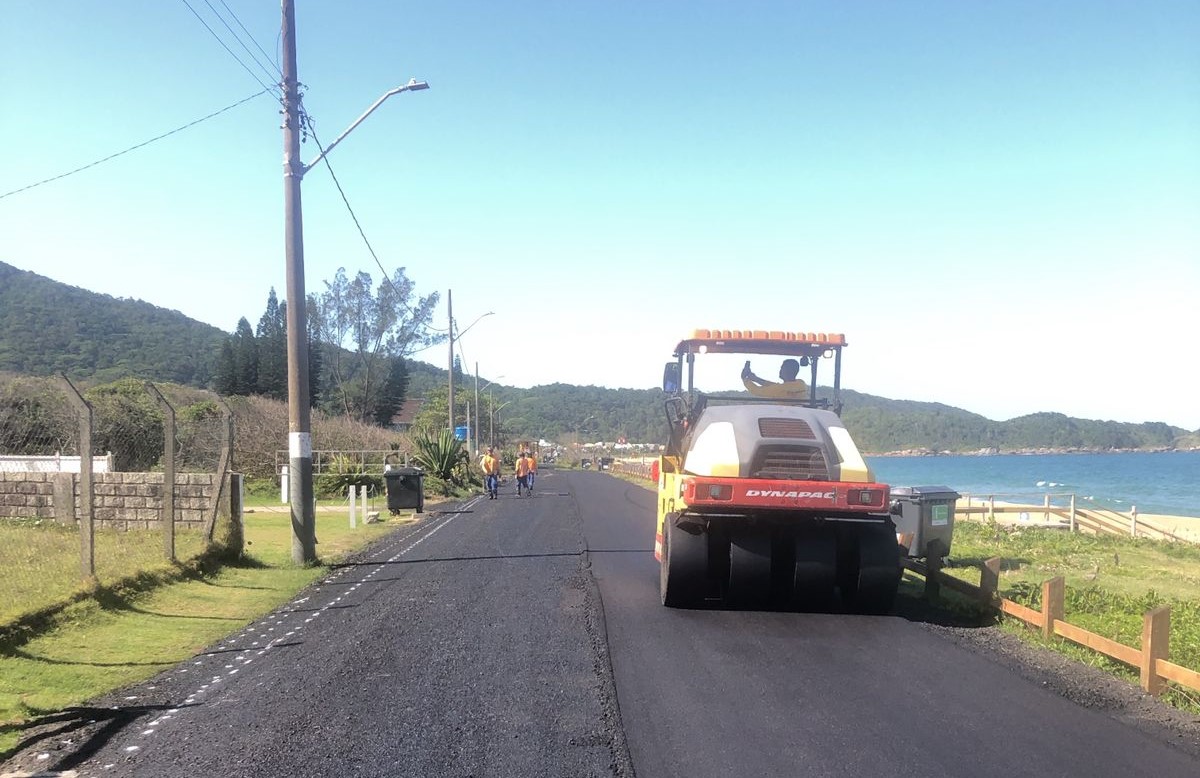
(0, 375), (233, 632)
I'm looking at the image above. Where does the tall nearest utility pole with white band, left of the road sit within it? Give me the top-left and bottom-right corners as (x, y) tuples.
(282, 0), (317, 564)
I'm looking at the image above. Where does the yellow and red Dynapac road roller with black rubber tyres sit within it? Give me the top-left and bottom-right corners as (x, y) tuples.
(654, 329), (901, 614)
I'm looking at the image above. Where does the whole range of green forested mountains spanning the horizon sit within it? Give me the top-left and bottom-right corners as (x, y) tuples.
(0, 263), (1200, 453)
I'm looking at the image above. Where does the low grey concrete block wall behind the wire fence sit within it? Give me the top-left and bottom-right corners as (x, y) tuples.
(0, 472), (220, 529)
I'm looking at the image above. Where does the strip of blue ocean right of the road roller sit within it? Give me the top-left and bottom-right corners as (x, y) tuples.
(866, 451), (1200, 517)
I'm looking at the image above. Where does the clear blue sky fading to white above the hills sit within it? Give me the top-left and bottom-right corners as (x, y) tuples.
(0, 0), (1200, 430)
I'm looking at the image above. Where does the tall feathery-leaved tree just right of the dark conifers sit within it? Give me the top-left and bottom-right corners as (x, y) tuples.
(308, 268), (444, 421)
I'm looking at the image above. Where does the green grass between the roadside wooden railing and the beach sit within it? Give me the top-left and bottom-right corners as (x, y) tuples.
(946, 521), (1200, 712)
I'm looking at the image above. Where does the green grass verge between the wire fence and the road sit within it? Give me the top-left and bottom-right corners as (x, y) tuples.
(0, 501), (409, 759)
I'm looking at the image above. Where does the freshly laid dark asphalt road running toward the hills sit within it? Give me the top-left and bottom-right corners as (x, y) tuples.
(9, 471), (1200, 778)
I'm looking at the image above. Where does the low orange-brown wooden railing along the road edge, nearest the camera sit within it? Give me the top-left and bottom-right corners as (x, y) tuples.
(905, 557), (1200, 695)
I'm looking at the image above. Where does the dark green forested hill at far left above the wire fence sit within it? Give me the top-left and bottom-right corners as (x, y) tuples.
(0, 262), (228, 387)
